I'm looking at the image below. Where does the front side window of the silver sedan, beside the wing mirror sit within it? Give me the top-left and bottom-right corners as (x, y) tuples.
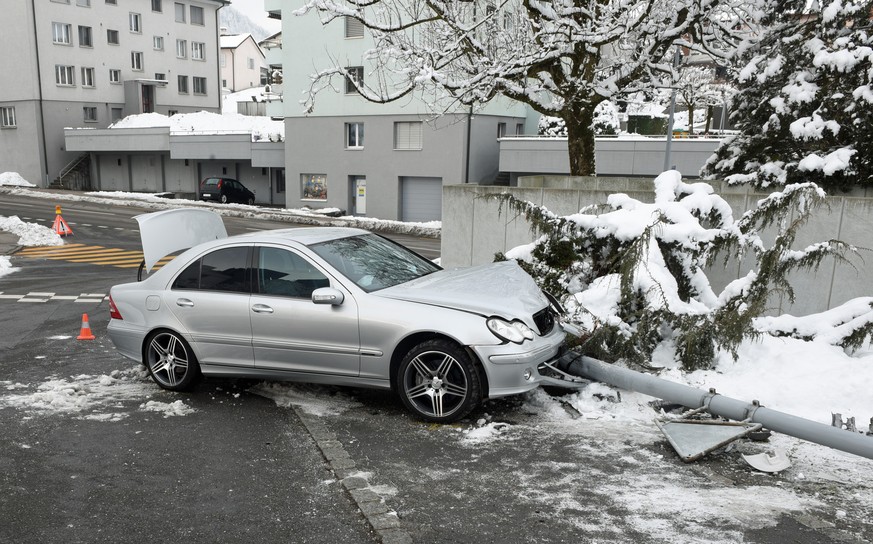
(257, 247), (330, 298)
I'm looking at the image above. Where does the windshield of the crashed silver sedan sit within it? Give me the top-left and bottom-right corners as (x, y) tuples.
(309, 234), (441, 292)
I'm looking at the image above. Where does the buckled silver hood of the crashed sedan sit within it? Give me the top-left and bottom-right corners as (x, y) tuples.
(374, 261), (549, 318)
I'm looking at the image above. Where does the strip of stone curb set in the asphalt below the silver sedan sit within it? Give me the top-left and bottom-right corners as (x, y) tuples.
(294, 407), (412, 544)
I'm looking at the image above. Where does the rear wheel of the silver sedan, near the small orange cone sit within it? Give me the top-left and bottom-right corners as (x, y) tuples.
(143, 331), (200, 391)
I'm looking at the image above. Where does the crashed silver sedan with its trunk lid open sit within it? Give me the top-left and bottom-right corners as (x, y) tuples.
(109, 209), (564, 422)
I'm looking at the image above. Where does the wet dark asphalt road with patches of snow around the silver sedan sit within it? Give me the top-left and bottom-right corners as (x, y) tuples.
(0, 189), (873, 544)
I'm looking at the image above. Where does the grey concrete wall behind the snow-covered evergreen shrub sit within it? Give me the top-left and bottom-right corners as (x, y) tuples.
(441, 176), (873, 315)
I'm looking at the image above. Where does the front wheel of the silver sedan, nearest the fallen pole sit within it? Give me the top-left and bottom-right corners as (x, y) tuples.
(396, 340), (482, 423)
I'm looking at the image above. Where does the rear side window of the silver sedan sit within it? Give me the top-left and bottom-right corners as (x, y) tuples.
(173, 247), (250, 293)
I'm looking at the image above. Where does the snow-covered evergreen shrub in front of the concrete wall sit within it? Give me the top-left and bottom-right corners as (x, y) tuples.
(486, 171), (873, 370)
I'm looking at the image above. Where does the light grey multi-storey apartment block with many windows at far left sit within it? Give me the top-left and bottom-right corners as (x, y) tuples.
(0, 0), (230, 186)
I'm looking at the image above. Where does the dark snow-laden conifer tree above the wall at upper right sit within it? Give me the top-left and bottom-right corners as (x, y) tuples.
(703, 0), (873, 190)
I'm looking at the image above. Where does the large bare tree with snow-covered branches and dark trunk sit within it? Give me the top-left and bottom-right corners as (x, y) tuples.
(296, 0), (768, 175)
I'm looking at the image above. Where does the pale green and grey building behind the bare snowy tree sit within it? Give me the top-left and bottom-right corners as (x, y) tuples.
(264, 0), (536, 221)
